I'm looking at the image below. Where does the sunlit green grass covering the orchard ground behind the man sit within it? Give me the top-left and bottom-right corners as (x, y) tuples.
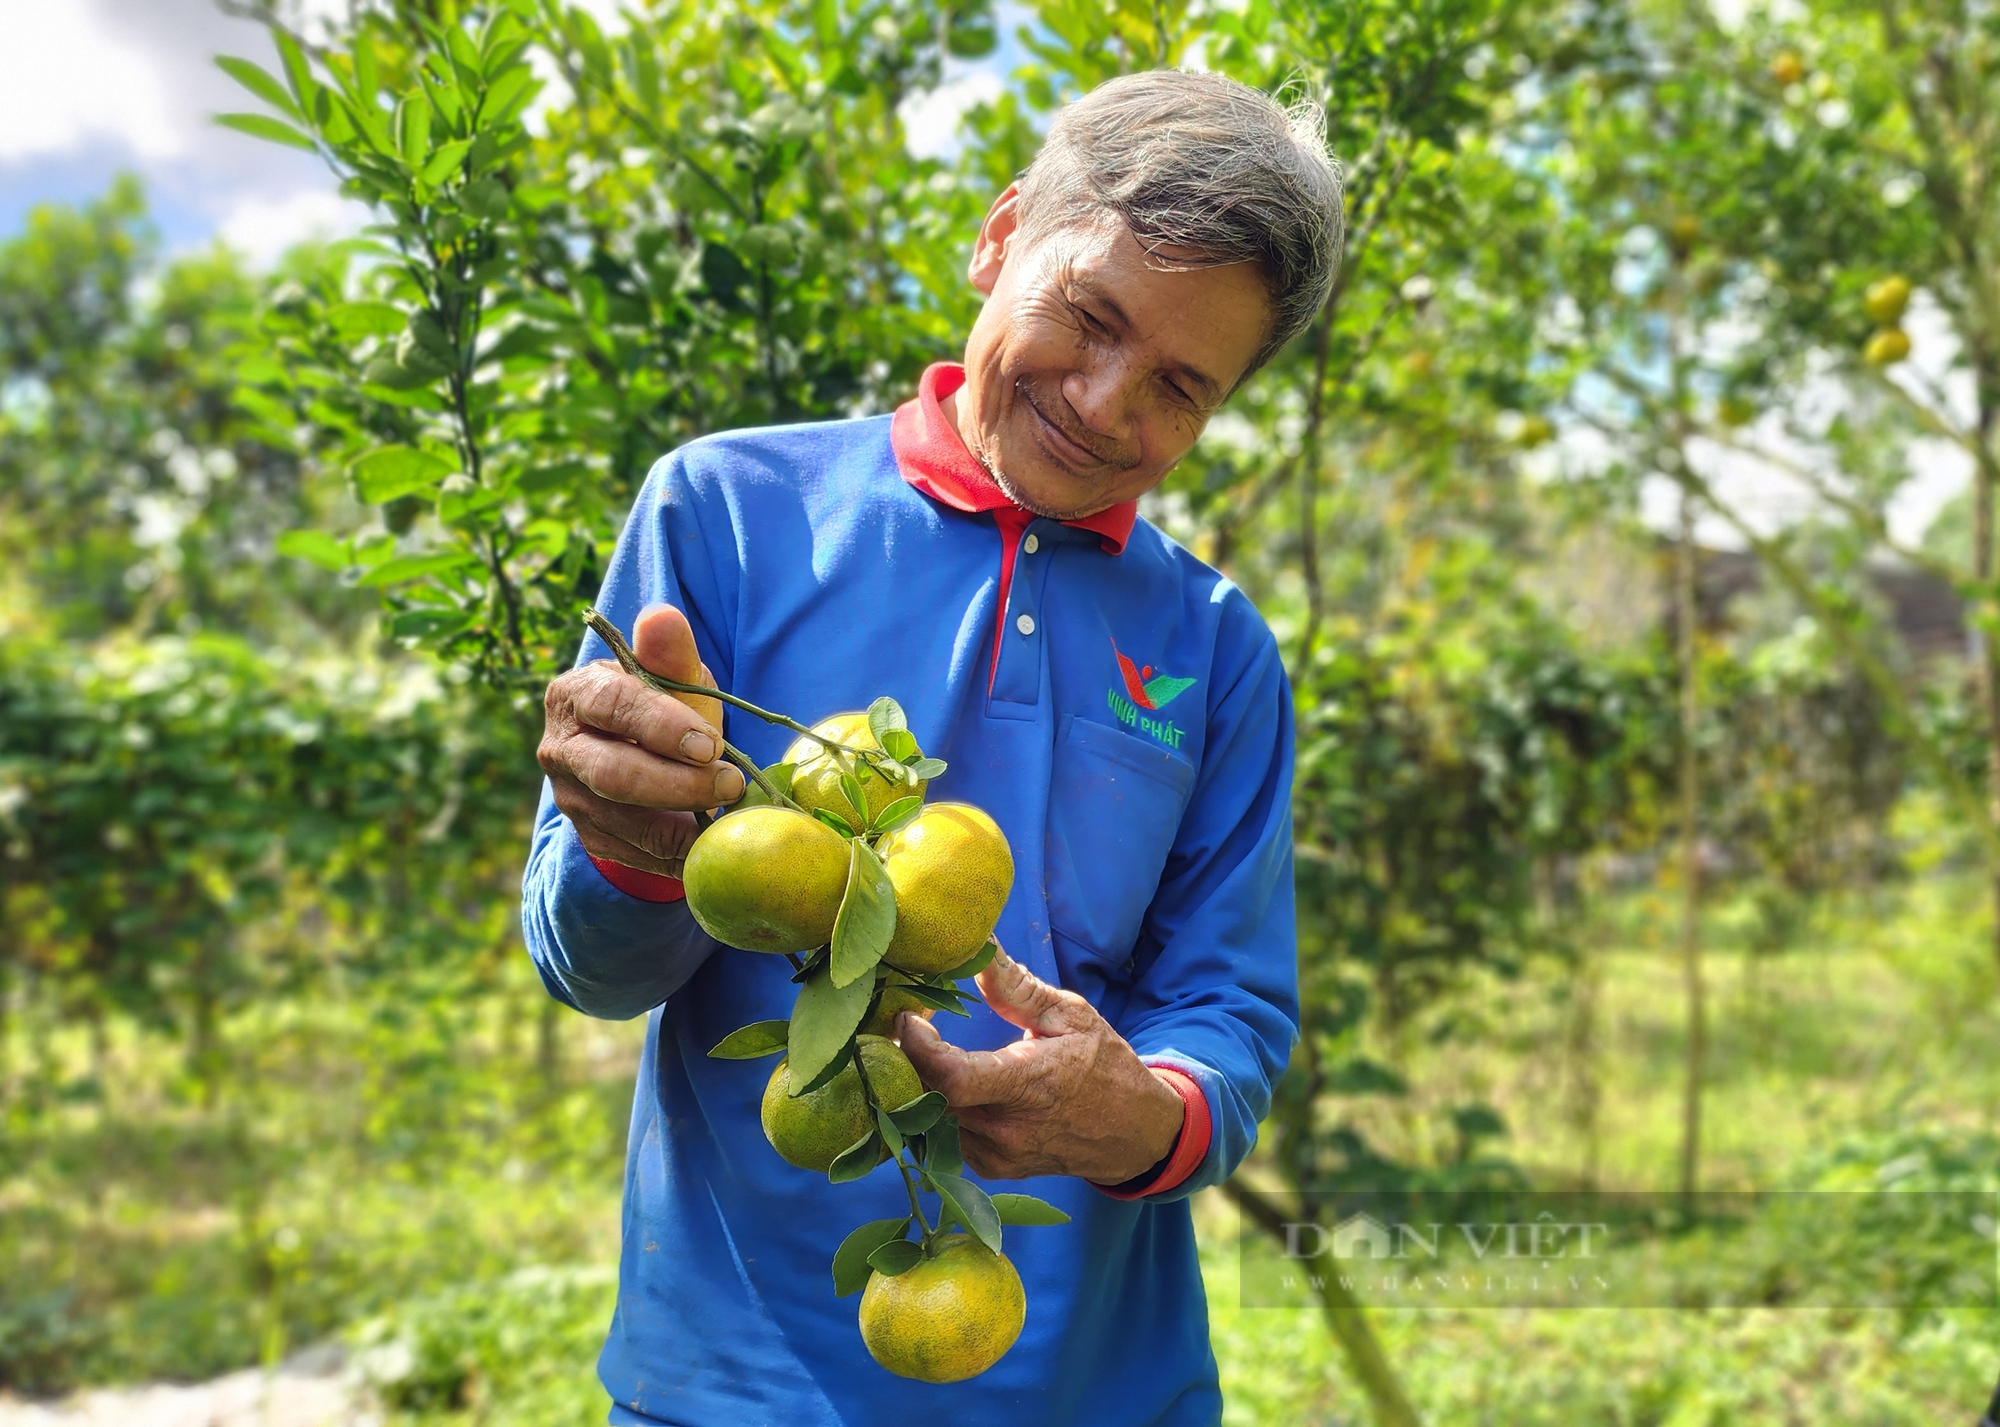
(0, 877), (2000, 1427)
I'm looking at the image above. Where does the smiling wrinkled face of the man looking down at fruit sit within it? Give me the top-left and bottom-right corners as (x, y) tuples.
(946, 188), (1270, 520)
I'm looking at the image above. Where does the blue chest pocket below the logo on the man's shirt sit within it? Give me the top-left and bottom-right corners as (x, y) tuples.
(1046, 715), (1194, 965)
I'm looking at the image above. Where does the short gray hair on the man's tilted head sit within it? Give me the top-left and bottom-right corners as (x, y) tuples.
(1020, 70), (1344, 378)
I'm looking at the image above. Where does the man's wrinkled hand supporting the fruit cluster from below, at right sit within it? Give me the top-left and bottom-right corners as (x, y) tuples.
(898, 951), (1186, 1185)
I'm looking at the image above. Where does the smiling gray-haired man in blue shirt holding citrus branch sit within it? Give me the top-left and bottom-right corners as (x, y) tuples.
(524, 72), (1340, 1427)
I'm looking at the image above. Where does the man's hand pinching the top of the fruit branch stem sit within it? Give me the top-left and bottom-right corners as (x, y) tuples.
(536, 604), (744, 877)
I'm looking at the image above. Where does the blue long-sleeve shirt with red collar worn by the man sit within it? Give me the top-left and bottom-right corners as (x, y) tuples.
(522, 368), (1298, 1427)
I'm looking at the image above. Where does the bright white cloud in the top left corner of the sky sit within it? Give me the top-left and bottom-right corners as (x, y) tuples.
(0, 0), (188, 162)
